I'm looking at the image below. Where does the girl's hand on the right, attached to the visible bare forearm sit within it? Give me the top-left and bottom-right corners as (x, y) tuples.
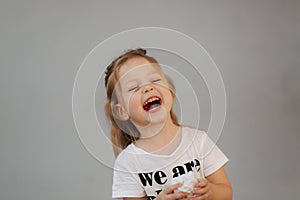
(189, 179), (212, 200)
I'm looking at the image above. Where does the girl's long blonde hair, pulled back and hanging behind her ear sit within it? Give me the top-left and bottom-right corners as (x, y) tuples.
(104, 48), (179, 156)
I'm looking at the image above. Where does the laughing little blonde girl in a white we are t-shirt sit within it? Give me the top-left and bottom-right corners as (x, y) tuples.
(105, 49), (232, 200)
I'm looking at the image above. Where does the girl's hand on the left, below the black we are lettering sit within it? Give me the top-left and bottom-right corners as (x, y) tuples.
(155, 183), (188, 200)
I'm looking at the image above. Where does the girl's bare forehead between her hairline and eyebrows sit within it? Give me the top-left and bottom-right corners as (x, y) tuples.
(119, 57), (162, 79)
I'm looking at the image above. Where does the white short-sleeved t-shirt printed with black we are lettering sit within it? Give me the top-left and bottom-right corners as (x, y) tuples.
(112, 127), (228, 200)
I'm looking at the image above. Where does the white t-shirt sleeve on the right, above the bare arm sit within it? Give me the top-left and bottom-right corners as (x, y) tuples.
(202, 133), (229, 176)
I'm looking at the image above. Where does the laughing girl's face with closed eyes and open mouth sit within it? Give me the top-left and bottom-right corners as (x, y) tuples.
(118, 57), (173, 127)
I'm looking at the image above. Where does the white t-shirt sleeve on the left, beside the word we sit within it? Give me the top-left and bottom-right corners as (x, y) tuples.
(112, 152), (146, 198)
